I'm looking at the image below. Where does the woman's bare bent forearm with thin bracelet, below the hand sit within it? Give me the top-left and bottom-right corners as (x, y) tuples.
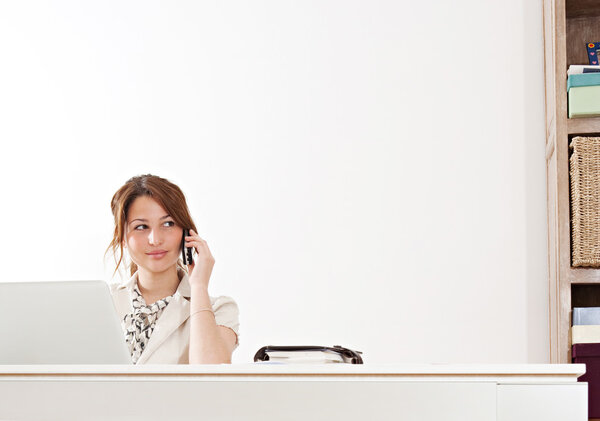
(189, 285), (236, 364)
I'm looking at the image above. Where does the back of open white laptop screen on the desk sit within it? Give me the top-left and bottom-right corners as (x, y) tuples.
(0, 281), (132, 364)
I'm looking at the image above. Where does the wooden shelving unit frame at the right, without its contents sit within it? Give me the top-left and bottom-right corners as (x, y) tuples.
(543, 0), (600, 363)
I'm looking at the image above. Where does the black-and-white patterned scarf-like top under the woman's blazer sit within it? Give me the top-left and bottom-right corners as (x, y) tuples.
(122, 283), (173, 364)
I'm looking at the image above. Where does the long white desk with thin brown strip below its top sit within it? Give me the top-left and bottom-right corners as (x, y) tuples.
(0, 364), (587, 421)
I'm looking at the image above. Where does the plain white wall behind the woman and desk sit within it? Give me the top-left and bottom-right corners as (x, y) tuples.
(0, 0), (548, 362)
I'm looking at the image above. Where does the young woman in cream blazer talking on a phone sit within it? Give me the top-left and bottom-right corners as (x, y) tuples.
(107, 175), (239, 364)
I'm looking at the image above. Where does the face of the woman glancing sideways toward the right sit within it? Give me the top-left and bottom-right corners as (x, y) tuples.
(125, 196), (183, 273)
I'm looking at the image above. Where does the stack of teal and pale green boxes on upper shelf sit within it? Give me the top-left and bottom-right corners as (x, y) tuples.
(567, 65), (600, 118)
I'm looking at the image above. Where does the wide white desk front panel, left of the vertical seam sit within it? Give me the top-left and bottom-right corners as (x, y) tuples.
(0, 378), (497, 421)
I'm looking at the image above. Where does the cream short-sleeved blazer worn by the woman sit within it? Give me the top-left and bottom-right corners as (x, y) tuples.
(110, 269), (239, 364)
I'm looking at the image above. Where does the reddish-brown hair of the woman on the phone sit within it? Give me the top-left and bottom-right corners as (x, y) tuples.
(105, 174), (196, 275)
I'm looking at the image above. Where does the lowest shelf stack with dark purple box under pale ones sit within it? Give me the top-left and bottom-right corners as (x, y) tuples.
(571, 307), (600, 418)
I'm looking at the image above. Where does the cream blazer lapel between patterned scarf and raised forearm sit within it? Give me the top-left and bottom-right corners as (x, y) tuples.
(137, 273), (191, 364)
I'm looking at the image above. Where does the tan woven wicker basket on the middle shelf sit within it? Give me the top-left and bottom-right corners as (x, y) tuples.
(570, 137), (600, 267)
